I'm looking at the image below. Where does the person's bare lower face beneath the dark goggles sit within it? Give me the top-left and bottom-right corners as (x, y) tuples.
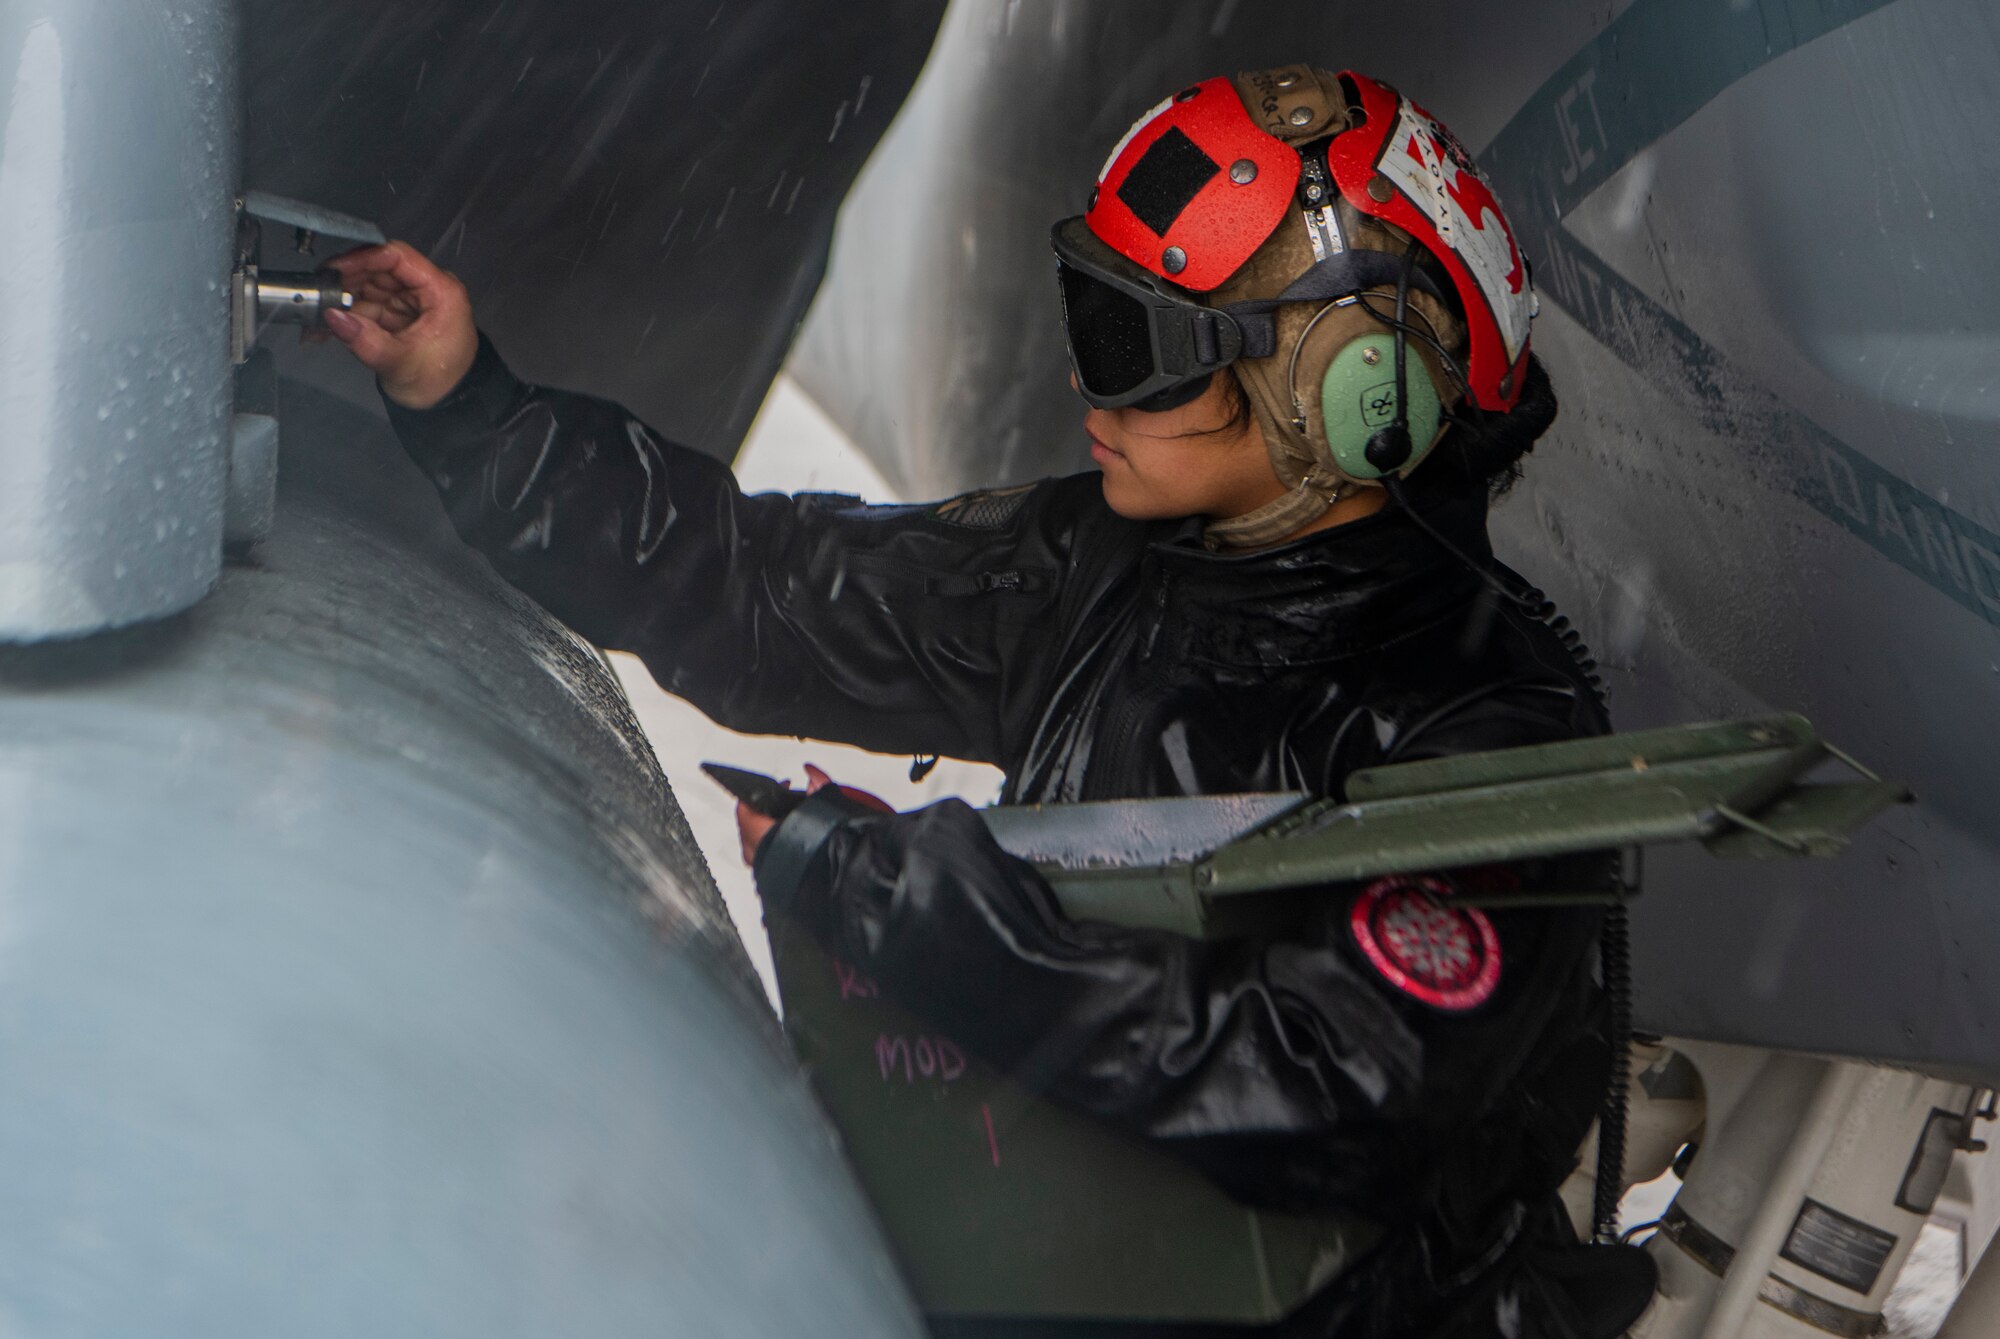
(1072, 374), (1284, 522)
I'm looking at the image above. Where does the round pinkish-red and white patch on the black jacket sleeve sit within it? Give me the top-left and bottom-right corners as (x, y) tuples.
(1348, 877), (1500, 1013)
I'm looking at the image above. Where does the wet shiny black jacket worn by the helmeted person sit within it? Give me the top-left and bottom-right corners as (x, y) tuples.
(392, 333), (1604, 1333)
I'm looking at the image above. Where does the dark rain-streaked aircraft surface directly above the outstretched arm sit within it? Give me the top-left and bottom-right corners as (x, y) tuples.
(244, 0), (944, 458)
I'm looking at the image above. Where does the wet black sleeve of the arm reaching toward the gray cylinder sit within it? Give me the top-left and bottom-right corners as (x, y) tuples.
(390, 338), (1102, 761)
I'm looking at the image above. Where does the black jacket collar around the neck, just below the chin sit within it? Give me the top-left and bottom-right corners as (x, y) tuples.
(1146, 494), (1492, 668)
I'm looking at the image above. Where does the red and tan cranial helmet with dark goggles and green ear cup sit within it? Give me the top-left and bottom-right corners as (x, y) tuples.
(1052, 66), (1534, 546)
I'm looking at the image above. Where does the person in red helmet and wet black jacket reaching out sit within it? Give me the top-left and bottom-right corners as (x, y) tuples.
(328, 66), (1630, 1337)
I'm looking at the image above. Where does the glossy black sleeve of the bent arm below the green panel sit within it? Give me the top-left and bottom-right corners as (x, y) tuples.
(760, 801), (1596, 1219)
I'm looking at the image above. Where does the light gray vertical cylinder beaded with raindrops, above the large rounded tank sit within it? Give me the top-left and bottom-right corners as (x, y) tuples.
(0, 0), (238, 642)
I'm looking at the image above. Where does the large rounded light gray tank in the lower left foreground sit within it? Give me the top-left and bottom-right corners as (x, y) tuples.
(0, 388), (918, 1339)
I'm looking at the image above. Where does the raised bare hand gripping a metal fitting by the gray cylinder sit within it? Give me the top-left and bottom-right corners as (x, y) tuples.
(326, 242), (480, 410)
